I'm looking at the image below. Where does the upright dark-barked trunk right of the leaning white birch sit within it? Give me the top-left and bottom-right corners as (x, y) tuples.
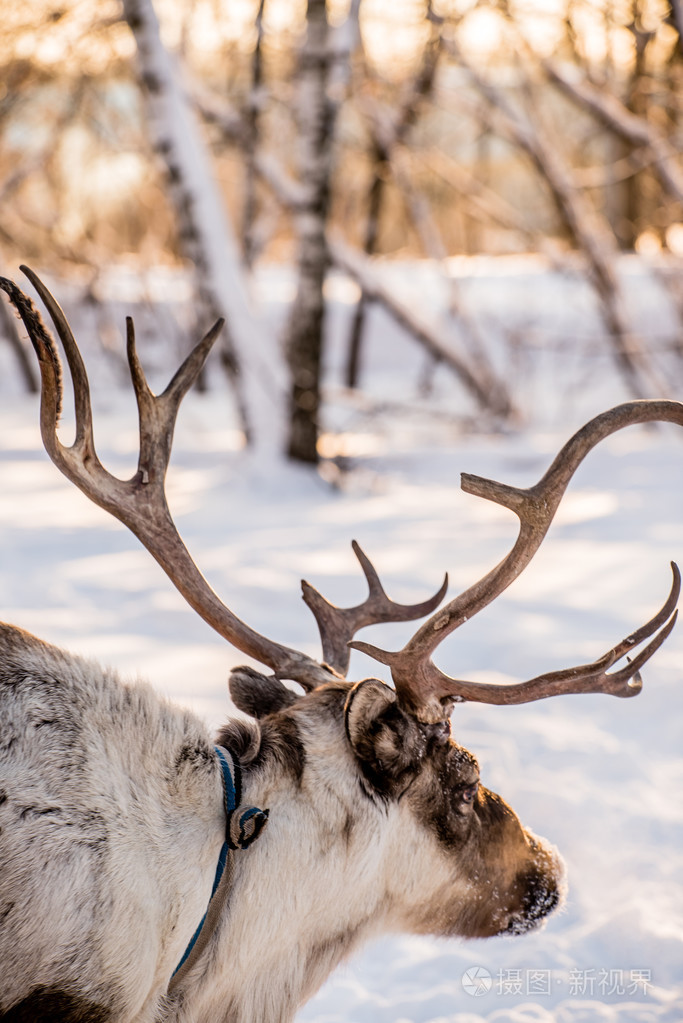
(285, 0), (335, 463)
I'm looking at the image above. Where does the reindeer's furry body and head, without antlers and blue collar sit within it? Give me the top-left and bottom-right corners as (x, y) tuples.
(0, 625), (562, 1023)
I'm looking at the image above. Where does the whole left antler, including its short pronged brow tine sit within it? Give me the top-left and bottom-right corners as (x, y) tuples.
(0, 266), (446, 691)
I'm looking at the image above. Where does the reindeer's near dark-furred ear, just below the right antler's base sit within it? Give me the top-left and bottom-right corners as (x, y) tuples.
(345, 678), (426, 795)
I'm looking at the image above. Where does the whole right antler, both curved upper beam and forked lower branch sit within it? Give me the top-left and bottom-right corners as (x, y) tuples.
(351, 400), (683, 721)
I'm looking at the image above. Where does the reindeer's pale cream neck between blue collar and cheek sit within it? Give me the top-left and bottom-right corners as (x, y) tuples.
(179, 752), (389, 1023)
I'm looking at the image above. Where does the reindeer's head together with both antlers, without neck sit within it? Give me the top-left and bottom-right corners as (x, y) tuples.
(0, 270), (683, 949)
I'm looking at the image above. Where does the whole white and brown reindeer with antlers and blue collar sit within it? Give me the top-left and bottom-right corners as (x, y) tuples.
(0, 269), (683, 1023)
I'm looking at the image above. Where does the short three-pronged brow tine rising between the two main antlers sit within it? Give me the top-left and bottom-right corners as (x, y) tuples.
(302, 540), (448, 676)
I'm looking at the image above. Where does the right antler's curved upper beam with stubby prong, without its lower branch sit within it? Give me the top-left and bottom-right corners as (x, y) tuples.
(351, 400), (683, 721)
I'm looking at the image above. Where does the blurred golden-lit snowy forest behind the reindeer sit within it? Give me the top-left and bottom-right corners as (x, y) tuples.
(0, 0), (683, 462)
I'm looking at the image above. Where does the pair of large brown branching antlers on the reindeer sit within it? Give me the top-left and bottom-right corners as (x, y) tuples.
(0, 267), (683, 722)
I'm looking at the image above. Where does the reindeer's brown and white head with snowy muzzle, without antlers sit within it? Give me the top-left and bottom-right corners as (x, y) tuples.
(223, 669), (563, 938)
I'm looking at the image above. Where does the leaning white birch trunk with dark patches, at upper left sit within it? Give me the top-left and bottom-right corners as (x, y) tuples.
(118, 0), (258, 438)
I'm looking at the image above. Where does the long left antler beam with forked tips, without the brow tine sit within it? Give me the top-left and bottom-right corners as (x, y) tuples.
(6, 270), (332, 685)
